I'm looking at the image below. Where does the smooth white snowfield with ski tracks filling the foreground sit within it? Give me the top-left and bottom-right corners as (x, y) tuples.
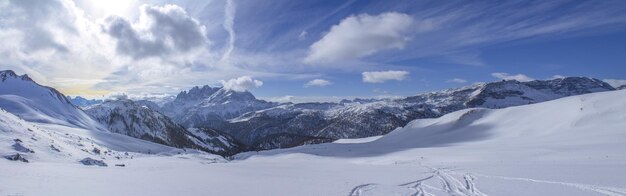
(0, 91), (626, 196)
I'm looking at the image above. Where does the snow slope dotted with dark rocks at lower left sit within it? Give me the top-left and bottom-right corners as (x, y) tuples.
(0, 108), (201, 164)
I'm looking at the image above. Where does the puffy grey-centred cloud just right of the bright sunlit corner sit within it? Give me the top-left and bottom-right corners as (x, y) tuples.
(103, 4), (209, 59)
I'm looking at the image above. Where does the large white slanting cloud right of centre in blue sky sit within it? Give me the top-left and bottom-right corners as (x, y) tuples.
(305, 12), (413, 63)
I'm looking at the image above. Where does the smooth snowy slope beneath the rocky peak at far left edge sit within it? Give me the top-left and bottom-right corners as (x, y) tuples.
(0, 70), (104, 130)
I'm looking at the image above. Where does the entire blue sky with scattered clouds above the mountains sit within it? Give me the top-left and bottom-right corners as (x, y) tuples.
(0, 0), (626, 101)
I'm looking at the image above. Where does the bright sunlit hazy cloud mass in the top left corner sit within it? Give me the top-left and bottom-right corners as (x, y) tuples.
(0, 0), (120, 93)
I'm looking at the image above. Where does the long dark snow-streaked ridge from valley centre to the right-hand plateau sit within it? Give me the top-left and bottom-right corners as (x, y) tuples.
(191, 77), (615, 149)
